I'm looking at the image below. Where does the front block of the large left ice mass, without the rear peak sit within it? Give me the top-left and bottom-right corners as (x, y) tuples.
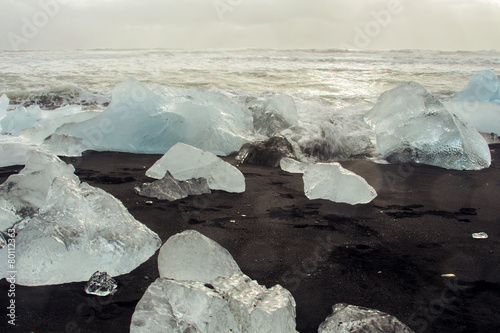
(9, 177), (161, 286)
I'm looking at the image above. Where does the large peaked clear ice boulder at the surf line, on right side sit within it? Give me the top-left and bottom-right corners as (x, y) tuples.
(365, 82), (491, 170)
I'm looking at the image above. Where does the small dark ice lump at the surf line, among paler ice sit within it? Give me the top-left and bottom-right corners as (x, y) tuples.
(236, 136), (294, 167)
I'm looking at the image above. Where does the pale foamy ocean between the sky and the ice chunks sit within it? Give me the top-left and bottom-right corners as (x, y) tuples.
(0, 49), (500, 160)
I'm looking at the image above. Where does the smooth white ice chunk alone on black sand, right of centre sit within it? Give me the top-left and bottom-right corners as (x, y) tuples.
(303, 163), (377, 205)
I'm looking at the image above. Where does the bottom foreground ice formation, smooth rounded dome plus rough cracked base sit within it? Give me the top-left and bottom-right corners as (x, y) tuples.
(130, 230), (295, 333)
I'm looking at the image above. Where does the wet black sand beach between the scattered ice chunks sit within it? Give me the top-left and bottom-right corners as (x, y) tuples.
(0, 145), (500, 333)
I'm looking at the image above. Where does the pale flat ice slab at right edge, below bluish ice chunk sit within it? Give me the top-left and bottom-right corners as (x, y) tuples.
(443, 101), (500, 135)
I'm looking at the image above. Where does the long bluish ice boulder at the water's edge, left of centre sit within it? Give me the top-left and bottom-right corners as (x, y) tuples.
(57, 78), (253, 155)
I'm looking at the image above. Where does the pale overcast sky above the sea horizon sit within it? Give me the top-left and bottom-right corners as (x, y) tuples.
(0, 0), (500, 50)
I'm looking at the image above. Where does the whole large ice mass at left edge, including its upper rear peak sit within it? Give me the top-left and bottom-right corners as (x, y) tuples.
(0, 151), (161, 286)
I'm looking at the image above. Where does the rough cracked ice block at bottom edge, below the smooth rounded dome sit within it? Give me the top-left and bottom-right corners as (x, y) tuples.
(130, 274), (295, 333)
